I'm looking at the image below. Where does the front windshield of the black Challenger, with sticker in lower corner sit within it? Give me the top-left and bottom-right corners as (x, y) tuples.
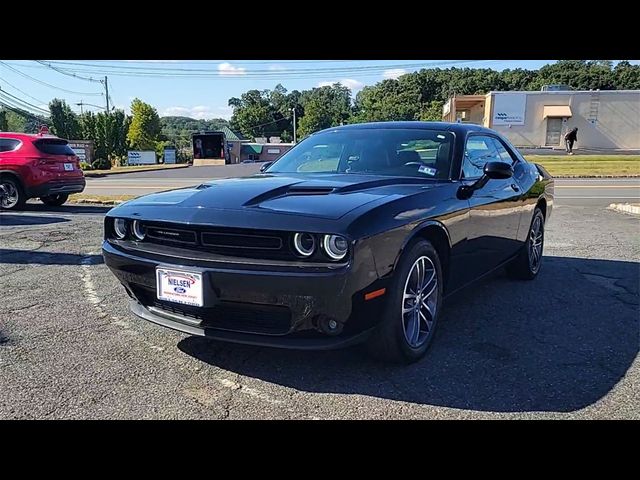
(266, 128), (453, 179)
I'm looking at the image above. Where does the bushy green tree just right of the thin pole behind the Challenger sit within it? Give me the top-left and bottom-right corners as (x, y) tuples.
(299, 83), (352, 137)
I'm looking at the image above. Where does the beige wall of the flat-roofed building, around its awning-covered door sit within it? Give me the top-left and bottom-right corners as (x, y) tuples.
(485, 90), (640, 149)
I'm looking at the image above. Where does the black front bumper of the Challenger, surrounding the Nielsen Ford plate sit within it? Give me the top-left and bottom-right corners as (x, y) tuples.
(102, 241), (384, 349)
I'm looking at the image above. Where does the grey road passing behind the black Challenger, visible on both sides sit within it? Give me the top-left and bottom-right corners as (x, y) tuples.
(84, 164), (640, 206)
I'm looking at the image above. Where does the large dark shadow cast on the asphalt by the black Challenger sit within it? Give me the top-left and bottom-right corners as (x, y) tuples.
(178, 257), (640, 412)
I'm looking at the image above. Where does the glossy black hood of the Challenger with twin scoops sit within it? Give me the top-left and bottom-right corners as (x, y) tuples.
(127, 174), (438, 219)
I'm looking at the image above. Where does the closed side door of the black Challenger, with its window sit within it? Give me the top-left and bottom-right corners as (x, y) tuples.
(460, 134), (523, 278)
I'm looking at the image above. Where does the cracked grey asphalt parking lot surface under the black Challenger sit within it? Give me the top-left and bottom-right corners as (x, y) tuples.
(0, 204), (640, 419)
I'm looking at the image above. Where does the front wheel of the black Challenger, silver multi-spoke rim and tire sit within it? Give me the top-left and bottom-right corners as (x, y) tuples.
(368, 240), (442, 363)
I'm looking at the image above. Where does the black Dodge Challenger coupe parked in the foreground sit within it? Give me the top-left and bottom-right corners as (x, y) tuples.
(102, 122), (553, 362)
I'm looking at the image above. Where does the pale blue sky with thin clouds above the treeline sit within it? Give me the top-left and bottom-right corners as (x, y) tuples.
(0, 60), (640, 119)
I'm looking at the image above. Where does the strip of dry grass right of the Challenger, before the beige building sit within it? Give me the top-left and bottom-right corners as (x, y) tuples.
(526, 155), (640, 176)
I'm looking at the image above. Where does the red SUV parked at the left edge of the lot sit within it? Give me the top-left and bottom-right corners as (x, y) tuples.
(0, 132), (85, 210)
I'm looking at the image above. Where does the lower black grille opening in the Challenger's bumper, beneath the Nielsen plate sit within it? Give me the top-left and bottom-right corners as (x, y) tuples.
(132, 286), (291, 335)
